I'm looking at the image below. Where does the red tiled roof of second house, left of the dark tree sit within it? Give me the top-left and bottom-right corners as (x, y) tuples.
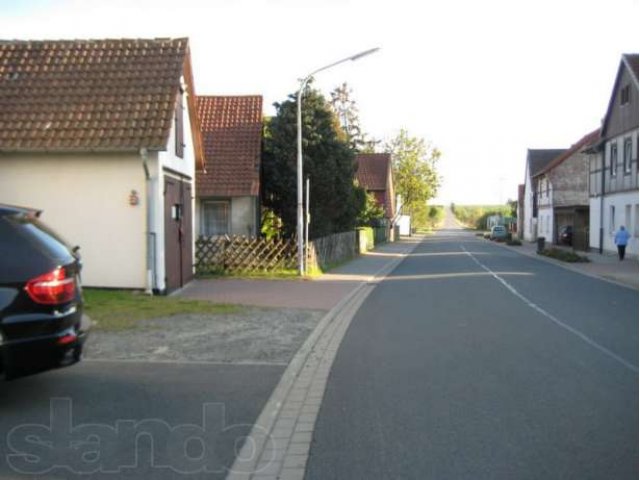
(196, 95), (262, 197)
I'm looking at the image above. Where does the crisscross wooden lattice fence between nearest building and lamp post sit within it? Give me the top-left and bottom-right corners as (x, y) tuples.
(196, 236), (297, 275)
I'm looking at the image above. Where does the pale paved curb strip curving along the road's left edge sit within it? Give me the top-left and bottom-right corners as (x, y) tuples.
(227, 242), (419, 480)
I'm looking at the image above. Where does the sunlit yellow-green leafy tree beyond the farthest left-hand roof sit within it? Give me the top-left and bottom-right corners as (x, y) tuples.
(385, 129), (441, 226)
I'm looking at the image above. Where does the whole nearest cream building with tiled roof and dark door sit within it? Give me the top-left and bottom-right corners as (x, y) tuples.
(0, 38), (203, 292)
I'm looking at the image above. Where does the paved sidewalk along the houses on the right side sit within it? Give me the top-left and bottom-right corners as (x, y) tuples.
(506, 242), (638, 290)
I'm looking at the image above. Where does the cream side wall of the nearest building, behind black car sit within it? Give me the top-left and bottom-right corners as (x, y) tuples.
(0, 154), (146, 288)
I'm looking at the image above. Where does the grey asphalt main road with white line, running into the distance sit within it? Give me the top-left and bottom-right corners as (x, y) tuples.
(305, 230), (638, 480)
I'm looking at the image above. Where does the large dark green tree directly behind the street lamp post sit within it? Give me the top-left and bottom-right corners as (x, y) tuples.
(262, 87), (364, 238)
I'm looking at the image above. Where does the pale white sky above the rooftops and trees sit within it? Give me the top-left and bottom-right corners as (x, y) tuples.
(0, 0), (640, 204)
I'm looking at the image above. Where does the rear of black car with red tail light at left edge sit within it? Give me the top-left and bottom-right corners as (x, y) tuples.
(0, 205), (89, 379)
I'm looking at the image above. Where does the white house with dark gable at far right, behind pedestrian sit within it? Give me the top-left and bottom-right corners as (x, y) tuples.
(589, 53), (638, 257)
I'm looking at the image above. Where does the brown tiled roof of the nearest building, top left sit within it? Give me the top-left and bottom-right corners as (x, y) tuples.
(0, 38), (190, 151)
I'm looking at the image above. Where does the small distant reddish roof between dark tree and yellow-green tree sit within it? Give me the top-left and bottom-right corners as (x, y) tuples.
(356, 153), (395, 218)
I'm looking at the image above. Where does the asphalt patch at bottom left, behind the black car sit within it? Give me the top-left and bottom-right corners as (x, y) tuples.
(0, 361), (285, 480)
